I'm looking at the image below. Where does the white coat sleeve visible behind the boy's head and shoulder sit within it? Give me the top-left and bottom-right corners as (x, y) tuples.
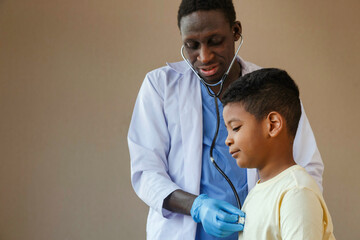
(293, 103), (324, 191)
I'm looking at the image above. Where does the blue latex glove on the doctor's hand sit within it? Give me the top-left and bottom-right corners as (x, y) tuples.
(190, 194), (245, 237)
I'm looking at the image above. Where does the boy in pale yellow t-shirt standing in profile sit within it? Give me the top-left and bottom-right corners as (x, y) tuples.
(222, 69), (335, 240)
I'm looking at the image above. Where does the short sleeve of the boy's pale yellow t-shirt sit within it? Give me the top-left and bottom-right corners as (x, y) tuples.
(280, 188), (324, 240)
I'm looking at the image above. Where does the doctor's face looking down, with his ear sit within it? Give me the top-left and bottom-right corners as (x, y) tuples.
(180, 10), (241, 83)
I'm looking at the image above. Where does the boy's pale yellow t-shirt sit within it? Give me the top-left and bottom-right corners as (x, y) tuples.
(239, 165), (335, 240)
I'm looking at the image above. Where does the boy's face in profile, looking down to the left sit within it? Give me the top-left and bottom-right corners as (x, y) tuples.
(223, 102), (268, 168)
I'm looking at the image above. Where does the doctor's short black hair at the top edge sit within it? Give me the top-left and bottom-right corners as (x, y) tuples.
(178, 0), (236, 29)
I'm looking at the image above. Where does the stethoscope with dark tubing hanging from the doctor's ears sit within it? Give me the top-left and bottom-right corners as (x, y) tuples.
(180, 34), (243, 209)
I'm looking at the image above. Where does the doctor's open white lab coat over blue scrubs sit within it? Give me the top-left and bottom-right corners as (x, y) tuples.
(128, 58), (323, 240)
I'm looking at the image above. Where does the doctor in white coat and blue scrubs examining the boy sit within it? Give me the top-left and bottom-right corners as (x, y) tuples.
(128, 0), (323, 239)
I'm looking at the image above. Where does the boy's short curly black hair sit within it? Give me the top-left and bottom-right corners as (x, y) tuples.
(221, 68), (301, 137)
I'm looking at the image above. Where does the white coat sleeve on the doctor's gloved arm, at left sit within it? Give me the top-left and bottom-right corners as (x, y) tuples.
(128, 72), (180, 217)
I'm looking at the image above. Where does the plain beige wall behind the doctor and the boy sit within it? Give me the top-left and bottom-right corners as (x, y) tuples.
(0, 0), (360, 240)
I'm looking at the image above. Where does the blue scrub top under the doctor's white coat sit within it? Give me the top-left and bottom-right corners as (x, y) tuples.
(196, 84), (248, 240)
